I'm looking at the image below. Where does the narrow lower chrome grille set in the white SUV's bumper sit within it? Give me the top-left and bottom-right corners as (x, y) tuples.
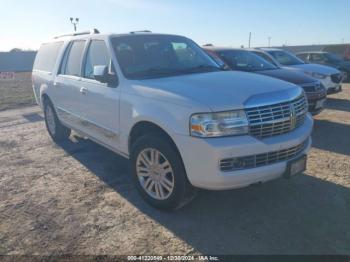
(220, 140), (307, 172)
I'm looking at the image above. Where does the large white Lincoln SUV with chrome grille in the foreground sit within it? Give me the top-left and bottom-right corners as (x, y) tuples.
(33, 32), (313, 209)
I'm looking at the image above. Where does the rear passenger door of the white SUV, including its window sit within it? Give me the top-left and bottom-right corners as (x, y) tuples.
(53, 40), (87, 131)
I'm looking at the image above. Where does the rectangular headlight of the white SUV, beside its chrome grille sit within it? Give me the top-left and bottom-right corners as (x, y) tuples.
(190, 110), (249, 137)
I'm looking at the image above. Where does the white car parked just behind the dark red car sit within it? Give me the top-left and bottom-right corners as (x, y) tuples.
(254, 48), (343, 93)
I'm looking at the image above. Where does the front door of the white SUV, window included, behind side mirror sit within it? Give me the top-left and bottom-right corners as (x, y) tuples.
(79, 39), (120, 147)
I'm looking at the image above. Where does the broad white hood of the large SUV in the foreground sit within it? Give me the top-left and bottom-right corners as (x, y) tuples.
(131, 71), (303, 111)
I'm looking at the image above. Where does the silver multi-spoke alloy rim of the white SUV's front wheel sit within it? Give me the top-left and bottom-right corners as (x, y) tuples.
(136, 148), (174, 200)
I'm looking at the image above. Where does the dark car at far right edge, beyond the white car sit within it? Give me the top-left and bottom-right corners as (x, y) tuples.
(296, 52), (350, 80)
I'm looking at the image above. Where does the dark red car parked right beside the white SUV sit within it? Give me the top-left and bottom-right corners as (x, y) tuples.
(204, 47), (327, 114)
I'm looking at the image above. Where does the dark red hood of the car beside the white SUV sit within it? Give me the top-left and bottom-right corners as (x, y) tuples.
(255, 68), (315, 85)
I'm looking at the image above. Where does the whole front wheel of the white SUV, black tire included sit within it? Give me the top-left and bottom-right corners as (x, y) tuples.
(130, 135), (196, 210)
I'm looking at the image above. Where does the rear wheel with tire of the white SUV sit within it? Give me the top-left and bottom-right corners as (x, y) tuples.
(44, 99), (71, 142)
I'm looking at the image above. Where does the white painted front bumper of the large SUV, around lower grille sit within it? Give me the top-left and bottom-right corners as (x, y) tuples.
(174, 114), (313, 190)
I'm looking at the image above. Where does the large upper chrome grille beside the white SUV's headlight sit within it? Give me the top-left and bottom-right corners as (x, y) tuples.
(245, 95), (308, 138)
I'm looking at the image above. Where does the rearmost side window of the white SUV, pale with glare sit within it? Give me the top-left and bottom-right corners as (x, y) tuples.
(33, 42), (63, 73)
